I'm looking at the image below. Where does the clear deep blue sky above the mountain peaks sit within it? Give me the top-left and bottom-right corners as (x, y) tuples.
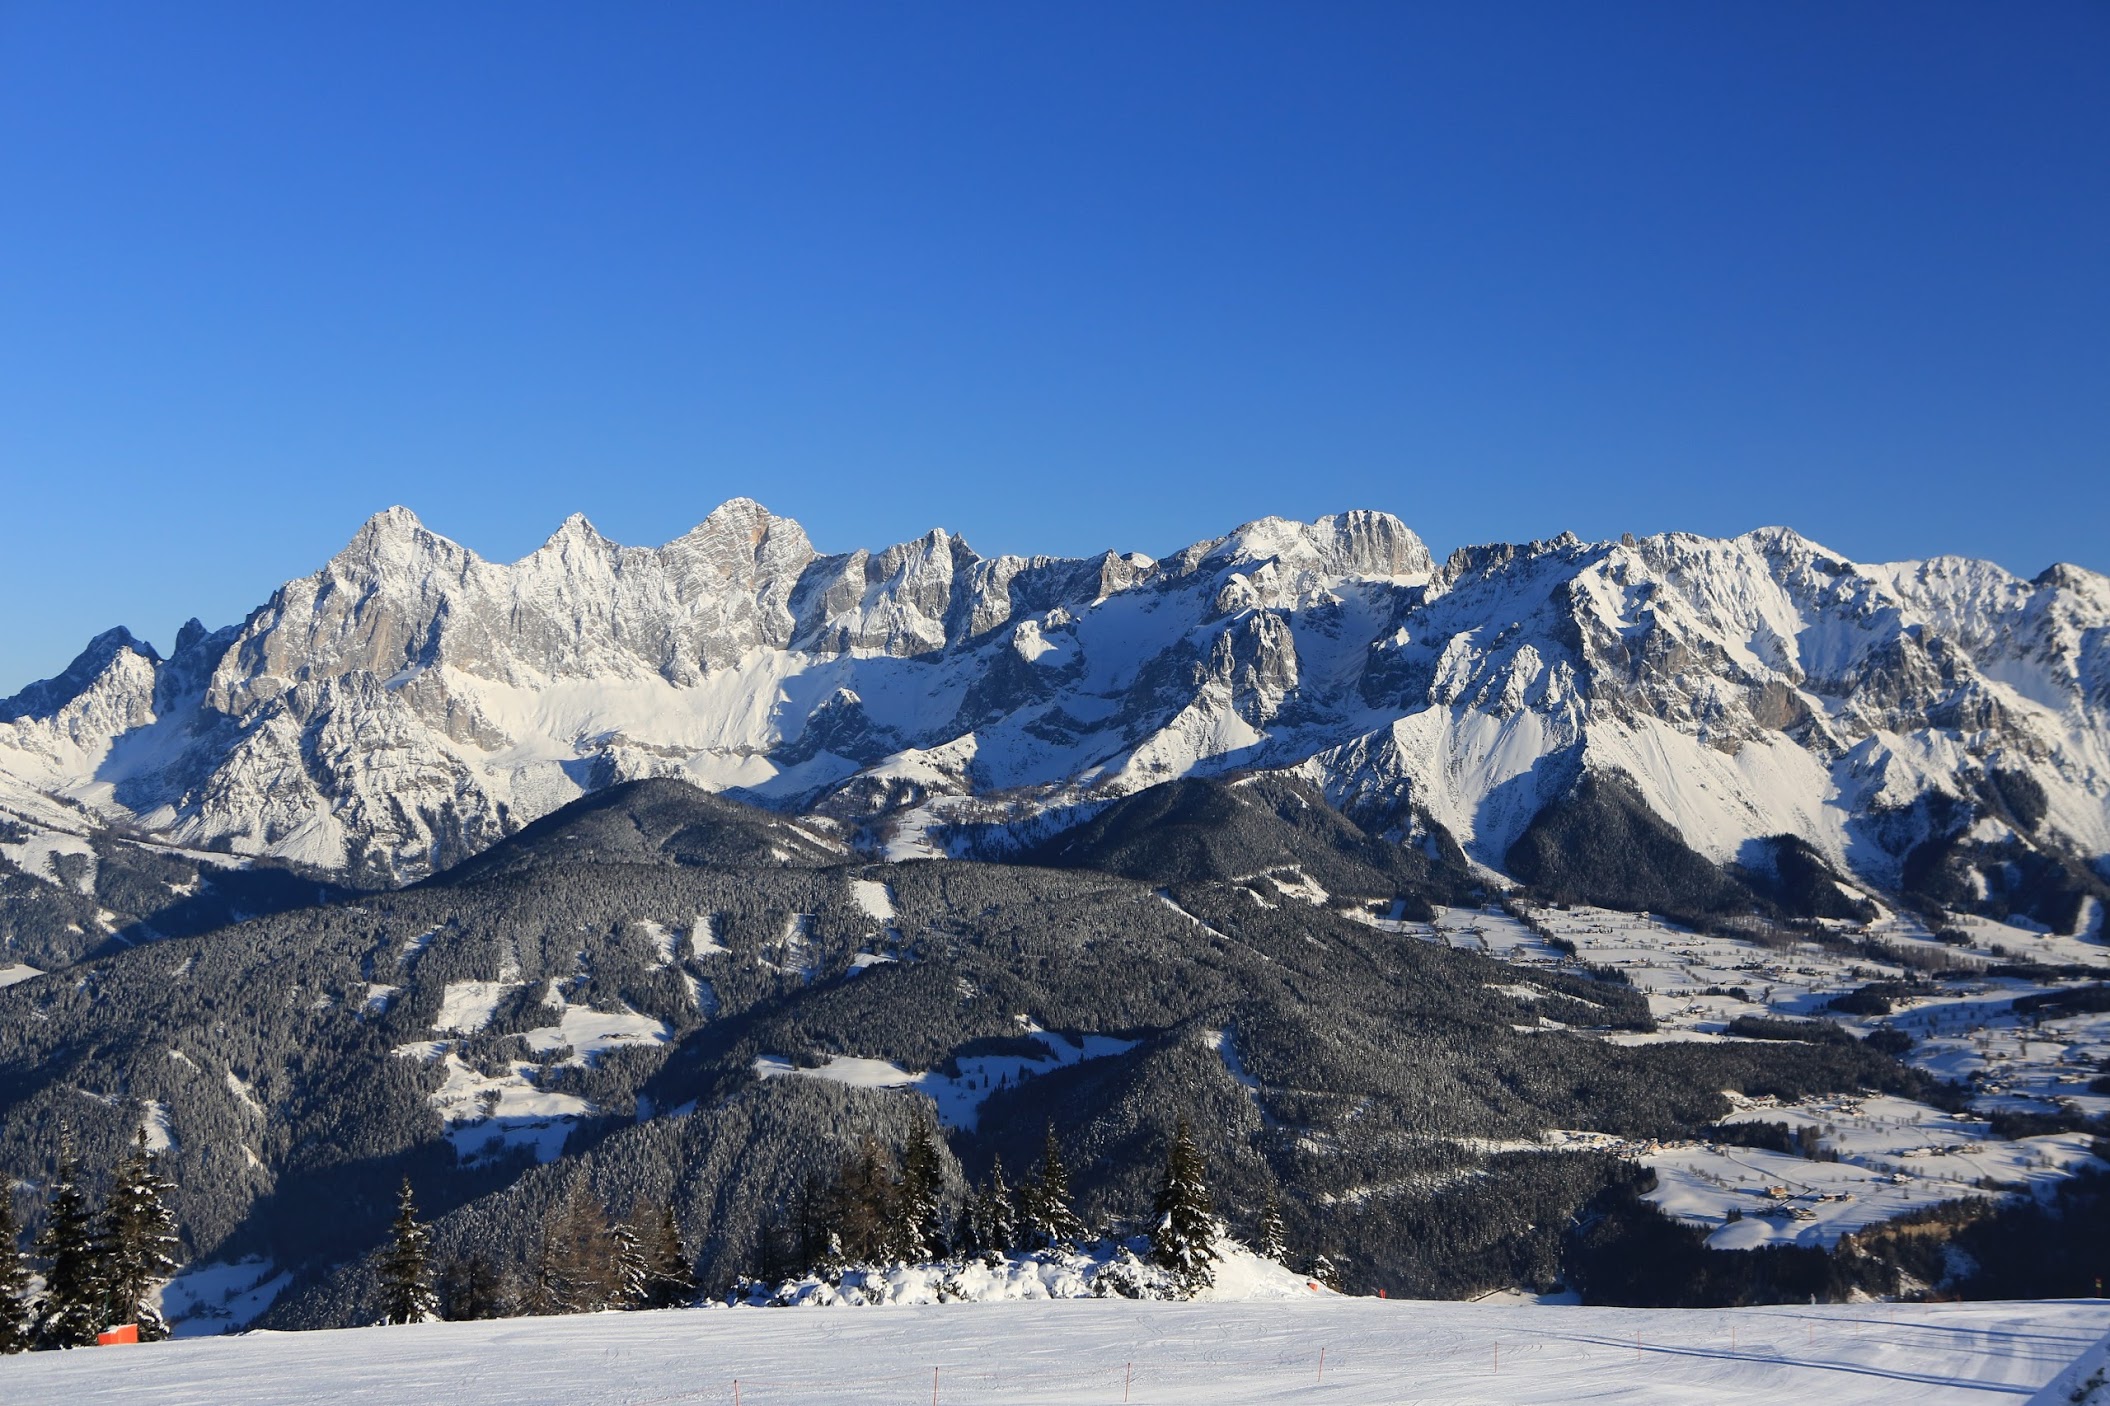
(0, 0), (2110, 692)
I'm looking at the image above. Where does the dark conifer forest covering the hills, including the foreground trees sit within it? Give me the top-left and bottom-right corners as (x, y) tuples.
(0, 781), (2093, 1347)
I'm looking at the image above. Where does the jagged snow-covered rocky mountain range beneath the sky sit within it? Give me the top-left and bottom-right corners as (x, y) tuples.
(0, 498), (2110, 931)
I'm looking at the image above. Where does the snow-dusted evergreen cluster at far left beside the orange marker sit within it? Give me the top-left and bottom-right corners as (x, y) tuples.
(0, 1125), (181, 1353)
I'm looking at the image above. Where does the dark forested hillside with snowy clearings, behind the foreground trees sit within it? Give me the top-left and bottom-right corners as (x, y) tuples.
(0, 781), (2008, 1326)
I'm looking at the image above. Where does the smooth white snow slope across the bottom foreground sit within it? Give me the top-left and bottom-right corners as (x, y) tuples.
(0, 1298), (2110, 1406)
